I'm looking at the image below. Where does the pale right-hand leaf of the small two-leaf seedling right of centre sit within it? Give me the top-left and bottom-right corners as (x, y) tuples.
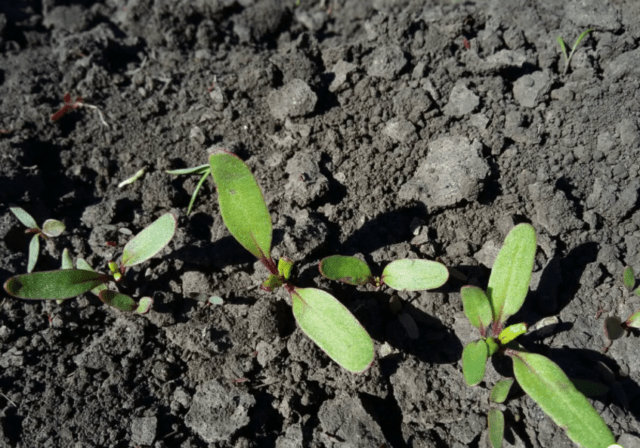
(382, 259), (449, 291)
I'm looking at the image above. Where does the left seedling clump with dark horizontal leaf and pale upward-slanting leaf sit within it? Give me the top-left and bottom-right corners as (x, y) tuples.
(4, 213), (176, 314)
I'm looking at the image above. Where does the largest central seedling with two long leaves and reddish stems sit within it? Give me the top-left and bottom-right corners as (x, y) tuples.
(209, 150), (374, 373)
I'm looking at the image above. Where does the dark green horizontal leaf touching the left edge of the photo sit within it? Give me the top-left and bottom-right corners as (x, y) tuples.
(4, 269), (109, 300)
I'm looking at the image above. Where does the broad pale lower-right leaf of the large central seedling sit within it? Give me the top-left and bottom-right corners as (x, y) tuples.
(291, 288), (374, 373)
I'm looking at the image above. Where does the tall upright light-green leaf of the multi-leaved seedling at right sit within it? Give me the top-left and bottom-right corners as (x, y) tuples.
(487, 224), (537, 328)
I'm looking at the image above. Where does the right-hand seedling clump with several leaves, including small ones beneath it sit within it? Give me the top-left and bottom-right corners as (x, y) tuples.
(461, 224), (615, 448)
